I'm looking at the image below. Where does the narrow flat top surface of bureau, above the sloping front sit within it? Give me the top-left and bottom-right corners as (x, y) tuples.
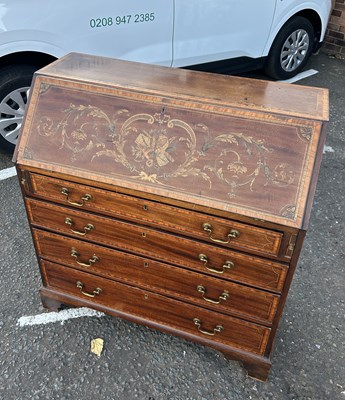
(36, 53), (329, 121)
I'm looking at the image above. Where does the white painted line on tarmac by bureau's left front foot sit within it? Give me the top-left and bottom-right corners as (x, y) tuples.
(17, 307), (105, 327)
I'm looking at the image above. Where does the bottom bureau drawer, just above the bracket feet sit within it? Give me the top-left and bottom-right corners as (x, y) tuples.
(41, 261), (270, 355)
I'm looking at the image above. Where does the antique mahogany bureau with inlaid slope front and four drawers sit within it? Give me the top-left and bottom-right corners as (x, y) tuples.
(14, 53), (328, 380)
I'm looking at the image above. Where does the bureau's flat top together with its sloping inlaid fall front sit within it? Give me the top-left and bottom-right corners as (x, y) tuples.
(15, 53), (328, 228)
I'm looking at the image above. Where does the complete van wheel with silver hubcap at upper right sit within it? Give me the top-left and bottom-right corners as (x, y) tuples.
(264, 16), (315, 79)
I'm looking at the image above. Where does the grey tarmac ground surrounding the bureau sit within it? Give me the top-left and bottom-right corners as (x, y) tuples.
(0, 52), (345, 400)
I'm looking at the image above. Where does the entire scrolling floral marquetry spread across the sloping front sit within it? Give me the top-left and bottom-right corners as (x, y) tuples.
(33, 104), (294, 198)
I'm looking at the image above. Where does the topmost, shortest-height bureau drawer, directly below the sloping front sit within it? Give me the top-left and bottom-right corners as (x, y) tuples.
(26, 174), (283, 256)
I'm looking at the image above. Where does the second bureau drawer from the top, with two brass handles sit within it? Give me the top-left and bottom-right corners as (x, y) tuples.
(26, 199), (287, 292)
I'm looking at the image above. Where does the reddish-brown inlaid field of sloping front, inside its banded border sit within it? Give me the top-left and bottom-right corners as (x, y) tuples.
(26, 86), (313, 220)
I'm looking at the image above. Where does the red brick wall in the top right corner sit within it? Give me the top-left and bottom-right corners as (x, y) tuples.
(323, 0), (345, 56)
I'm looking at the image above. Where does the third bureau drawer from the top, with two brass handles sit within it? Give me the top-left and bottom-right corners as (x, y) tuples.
(33, 229), (280, 324)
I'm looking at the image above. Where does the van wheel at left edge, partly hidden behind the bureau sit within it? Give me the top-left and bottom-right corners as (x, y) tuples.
(0, 65), (38, 152)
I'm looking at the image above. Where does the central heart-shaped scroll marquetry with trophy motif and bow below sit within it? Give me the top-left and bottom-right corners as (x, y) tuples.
(88, 108), (211, 185)
